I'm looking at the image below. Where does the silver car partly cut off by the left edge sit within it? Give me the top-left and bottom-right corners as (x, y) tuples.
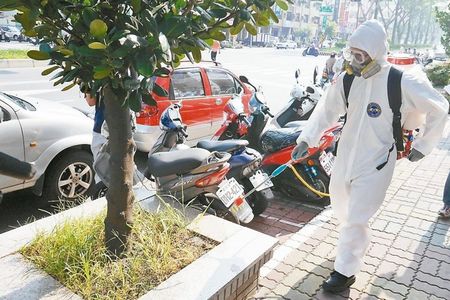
(0, 92), (94, 200)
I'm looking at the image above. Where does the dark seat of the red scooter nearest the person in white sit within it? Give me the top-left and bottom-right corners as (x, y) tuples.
(261, 128), (302, 153)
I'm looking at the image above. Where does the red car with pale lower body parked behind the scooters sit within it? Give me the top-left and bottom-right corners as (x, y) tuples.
(134, 63), (252, 152)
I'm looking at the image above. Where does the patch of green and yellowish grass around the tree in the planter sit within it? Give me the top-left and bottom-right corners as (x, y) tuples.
(21, 207), (215, 299)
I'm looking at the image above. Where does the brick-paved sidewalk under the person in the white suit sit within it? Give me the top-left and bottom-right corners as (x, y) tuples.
(253, 126), (450, 300)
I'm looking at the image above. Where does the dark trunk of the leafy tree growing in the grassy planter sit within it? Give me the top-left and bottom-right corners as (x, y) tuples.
(103, 86), (135, 257)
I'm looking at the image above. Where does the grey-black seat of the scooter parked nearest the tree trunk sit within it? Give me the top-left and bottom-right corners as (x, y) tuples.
(147, 148), (211, 177)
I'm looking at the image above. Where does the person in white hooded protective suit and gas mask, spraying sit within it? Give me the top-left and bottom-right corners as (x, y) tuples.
(292, 20), (448, 293)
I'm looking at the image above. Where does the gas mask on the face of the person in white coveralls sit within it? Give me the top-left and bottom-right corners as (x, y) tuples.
(344, 48), (381, 79)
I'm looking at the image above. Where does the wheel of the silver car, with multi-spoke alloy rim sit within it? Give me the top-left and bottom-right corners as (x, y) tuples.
(42, 150), (95, 201)
